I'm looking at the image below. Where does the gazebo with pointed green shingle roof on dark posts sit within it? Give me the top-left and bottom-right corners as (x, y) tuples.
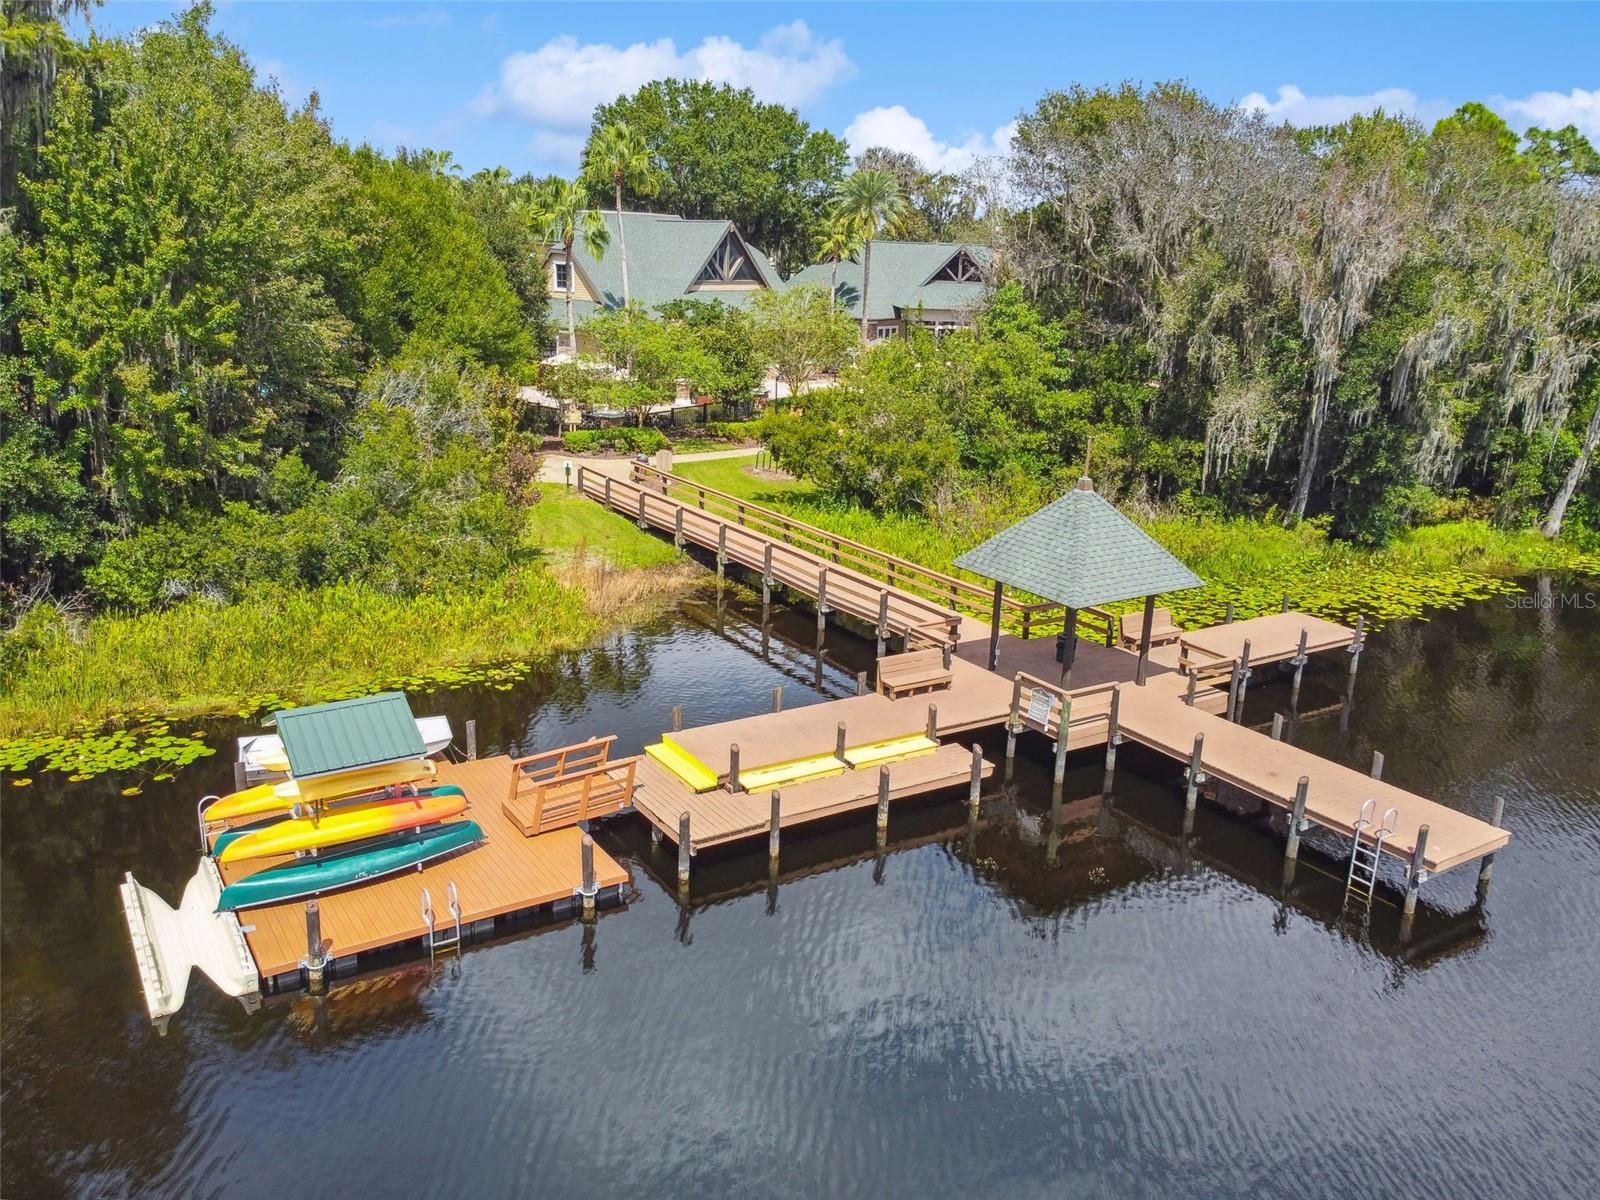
(955, 475), (1203, 686)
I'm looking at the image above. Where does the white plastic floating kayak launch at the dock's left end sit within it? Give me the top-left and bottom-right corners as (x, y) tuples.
(120, 858), (261, 1034)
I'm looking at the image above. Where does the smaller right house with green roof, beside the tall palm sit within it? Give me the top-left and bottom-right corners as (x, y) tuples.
(787, 238), (995, 341)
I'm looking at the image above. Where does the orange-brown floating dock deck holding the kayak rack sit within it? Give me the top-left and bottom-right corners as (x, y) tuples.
(221, 755), (629, 984)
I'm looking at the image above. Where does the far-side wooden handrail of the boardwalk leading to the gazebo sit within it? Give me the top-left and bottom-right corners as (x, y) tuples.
(632, 462), (1117, 646)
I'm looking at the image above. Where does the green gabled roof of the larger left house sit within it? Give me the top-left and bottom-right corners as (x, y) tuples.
(550, 213), (782, 320)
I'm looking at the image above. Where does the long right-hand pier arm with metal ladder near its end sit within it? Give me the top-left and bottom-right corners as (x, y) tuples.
(1118, 677), (1510, 875)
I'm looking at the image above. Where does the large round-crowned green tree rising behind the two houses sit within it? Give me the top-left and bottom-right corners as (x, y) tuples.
(594, 80), (848, 274)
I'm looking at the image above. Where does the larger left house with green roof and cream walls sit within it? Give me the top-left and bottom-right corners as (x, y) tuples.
(546, 213), (782, 349)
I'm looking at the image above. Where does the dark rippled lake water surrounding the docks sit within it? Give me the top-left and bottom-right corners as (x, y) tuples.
(0, 586), (1600, 1198)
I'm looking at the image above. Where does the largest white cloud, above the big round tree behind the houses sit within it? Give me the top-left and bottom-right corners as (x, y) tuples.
(478, 21), (856, 131)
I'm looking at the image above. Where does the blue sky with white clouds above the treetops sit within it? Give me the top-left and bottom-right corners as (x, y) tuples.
(94, 0), (1600, 171)
